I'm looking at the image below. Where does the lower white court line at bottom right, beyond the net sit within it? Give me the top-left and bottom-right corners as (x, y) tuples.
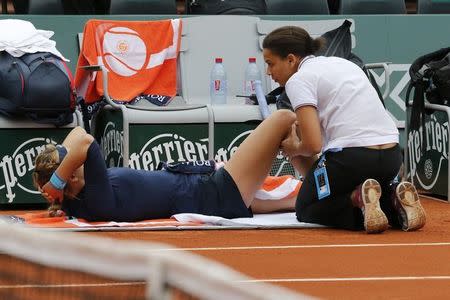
(237, 276), (450, 283)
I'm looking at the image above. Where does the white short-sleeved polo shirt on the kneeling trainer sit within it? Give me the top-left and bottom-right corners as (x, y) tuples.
(286, 56), (398, 151)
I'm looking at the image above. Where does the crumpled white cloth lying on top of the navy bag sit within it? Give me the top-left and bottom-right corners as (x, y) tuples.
(0, 19), (69, 61)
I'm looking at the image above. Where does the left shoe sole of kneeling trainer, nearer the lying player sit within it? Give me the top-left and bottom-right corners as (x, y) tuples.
(353, 179), (389, 233)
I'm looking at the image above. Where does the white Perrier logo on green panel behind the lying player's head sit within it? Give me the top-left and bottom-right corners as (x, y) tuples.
(0, 137), (56, 203)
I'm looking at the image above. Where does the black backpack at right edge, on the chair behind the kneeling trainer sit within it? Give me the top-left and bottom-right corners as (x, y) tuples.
(405, 47), (450, 151)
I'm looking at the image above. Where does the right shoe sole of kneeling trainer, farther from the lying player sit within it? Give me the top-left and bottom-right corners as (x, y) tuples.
(392, 181), (426, 231)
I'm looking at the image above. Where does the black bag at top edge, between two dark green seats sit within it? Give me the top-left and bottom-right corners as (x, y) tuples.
(186, 0), (267, 15)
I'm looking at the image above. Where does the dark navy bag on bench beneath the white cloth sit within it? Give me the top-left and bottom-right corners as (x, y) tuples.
(0, 51), (76, 126)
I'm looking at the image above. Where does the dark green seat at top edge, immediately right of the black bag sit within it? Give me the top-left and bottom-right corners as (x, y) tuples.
(266, 0), (330, 15)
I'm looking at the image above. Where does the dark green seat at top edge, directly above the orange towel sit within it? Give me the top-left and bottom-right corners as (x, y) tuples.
(109, 0), (177, 15)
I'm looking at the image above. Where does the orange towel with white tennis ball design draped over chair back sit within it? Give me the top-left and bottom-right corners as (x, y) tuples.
(75, 19), (182, 104)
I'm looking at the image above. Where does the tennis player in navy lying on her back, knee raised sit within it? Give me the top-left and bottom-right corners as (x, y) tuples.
(33, 110), (295, 221)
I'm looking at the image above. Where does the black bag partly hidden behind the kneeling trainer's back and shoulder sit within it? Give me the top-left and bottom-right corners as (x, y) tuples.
(269, 20), (385, 110)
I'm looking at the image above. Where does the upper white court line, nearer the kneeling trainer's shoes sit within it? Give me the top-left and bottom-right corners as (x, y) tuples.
(152, 242), (450, 252)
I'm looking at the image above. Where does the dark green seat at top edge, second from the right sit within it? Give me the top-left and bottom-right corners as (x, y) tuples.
(339, 0), (406, 15)
